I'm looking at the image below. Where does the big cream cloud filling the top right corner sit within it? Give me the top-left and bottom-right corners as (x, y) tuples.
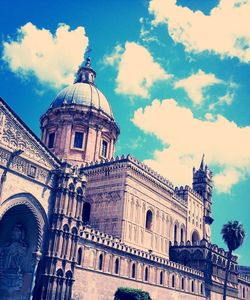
(149, 0), (250, 62)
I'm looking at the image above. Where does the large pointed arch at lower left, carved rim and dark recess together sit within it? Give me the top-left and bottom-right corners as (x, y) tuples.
(0, 194), (44, 299)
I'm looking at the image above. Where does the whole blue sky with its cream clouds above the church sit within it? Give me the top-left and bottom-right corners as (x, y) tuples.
(0, 0), (250, 265)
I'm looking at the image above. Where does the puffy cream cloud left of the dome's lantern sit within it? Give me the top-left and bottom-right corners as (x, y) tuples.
(2, 23), (88, 87)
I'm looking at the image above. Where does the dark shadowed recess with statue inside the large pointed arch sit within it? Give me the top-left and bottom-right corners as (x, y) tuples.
(0, 204), (39, 300)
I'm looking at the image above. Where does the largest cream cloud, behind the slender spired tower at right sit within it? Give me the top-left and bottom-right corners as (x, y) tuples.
(132, 99), (250, 192)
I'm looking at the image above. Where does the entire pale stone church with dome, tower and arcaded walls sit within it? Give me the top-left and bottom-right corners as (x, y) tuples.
(0, 58), (250, 300)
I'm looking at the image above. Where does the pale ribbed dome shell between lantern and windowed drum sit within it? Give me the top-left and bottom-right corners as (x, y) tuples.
(50, 82), (113, 118)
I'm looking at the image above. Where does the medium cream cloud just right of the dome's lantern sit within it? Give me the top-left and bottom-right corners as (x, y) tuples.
(104, 42), (170, 98)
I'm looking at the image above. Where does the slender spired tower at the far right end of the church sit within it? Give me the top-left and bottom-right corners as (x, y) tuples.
(193, 154), (213, 241)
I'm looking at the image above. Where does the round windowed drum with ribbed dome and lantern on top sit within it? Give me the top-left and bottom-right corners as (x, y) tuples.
(40, 57), (120, 166)
